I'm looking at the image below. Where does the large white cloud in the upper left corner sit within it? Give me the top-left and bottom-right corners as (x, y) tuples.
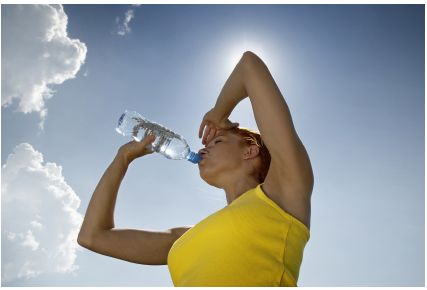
(1, 4), (87, 124)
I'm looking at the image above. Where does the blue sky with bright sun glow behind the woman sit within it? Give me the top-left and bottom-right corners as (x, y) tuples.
(1, 4), (425, 286)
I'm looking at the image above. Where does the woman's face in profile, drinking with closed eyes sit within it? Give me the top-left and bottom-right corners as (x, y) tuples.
(198, 130), (244, 187)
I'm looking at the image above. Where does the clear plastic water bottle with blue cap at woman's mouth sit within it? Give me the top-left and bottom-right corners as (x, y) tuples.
(116, 110), (201, 164)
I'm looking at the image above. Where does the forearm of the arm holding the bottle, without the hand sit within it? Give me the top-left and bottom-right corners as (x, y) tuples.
(79, 154), (128, 238)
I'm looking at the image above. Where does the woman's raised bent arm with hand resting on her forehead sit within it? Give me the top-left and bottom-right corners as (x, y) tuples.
(199, 51), (313, 192)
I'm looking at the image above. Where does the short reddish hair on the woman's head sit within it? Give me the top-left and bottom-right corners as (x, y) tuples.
(230, 127), (271, 183)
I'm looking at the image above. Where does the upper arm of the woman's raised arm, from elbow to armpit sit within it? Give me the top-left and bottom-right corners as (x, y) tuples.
(243, 52), (313, 191)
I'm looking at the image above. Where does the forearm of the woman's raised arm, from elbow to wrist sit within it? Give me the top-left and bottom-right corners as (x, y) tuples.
(215, 54), (248, 118)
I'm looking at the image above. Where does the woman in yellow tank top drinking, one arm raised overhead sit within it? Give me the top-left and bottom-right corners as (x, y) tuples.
(78, 51), (313, 286)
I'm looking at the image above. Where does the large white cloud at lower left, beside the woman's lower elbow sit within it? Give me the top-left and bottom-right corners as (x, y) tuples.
(1, 143), (83, 284)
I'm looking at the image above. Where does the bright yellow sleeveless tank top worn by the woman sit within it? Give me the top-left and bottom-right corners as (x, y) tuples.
(168, 184), (310, 286)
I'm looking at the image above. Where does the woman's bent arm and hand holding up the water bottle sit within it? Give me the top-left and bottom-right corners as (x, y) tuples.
(77, 135), (189, 265)
